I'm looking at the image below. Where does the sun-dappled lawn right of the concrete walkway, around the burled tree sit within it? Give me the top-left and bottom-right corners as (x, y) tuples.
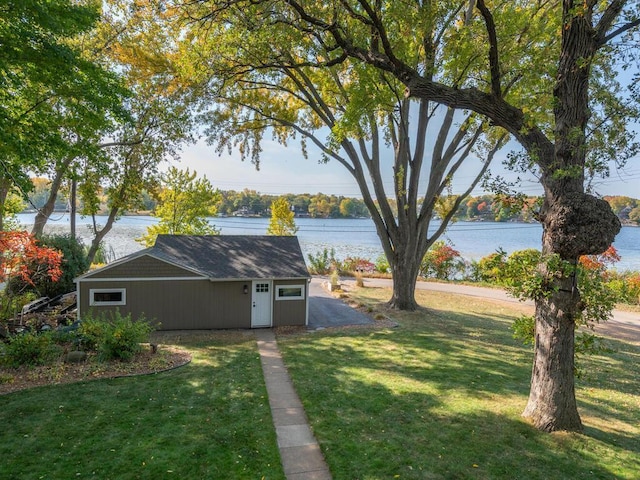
(278, 288), (640, 480)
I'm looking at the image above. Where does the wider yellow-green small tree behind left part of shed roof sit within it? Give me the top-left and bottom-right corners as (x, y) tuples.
(137, 167), (220, 247)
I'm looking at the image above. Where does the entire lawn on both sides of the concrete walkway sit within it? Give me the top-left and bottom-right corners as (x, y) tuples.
(0, 288), (640, 480)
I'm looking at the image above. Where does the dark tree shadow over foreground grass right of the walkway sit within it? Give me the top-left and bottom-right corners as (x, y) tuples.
(288, 354), (633, 480)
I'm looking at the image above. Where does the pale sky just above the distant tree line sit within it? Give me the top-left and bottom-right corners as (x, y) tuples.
(177, 131), (640, 198)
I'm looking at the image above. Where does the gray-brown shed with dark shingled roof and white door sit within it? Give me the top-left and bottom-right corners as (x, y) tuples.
(76, 235), (310, 330)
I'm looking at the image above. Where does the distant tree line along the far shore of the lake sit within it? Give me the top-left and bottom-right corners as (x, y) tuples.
(21, 178), (640, 225)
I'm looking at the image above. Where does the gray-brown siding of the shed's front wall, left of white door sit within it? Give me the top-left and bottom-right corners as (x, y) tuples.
(79, 280), (251, 330)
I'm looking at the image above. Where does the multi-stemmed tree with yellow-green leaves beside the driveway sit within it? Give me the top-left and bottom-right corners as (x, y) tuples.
(165, 1), (506, 309)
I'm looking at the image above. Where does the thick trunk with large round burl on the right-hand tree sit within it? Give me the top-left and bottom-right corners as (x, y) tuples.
(523, 0), (620, 432)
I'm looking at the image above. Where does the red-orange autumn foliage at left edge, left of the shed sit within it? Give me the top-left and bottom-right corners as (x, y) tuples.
(0, 231), (62, 286)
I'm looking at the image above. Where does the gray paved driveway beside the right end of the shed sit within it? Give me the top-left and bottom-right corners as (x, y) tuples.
(308, 277), (373, 330)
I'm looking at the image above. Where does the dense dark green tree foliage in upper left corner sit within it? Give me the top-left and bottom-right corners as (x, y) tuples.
(0, 0), (128, 228)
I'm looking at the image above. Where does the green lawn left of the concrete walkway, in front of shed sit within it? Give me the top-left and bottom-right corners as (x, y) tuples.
(0, 332), (284, 480)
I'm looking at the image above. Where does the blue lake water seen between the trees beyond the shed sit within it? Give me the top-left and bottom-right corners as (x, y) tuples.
(18, 214), (640, 271)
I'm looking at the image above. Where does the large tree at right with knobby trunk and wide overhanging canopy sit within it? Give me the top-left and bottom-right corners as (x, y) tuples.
(165, 0), (640, 431)
